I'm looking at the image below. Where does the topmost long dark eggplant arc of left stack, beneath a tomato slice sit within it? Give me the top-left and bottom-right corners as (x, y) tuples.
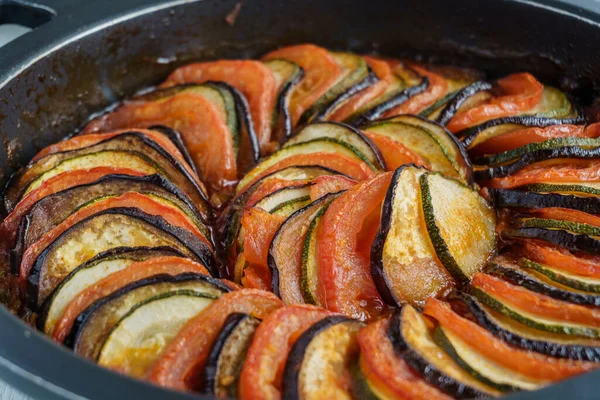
(4, 130), (211, 212)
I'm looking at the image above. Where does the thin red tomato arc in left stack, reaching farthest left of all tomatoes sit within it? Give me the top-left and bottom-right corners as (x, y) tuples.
(0, 167), (146, 268)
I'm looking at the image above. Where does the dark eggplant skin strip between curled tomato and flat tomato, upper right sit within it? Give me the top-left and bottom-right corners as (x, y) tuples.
(456, 115), (585, 149)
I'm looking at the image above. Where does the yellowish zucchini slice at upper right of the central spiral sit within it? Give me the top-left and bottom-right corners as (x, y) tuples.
(363, 115), (472, 183)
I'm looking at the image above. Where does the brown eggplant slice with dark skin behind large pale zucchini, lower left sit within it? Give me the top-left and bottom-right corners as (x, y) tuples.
(65, 273), (228, 361)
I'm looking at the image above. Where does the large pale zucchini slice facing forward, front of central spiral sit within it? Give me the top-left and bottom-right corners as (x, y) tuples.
(419, 173), (496, 283)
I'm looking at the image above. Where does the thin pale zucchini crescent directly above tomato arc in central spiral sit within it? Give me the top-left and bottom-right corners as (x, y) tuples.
(238, 137), (379, 188)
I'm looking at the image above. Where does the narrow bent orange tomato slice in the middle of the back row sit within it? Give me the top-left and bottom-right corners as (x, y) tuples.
(329, 56), (394, 121)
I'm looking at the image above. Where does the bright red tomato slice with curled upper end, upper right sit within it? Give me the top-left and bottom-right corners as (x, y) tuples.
(448, 73), (544, 133)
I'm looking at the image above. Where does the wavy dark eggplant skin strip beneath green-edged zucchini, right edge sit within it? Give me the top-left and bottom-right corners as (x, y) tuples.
(475, 146), (600, 180)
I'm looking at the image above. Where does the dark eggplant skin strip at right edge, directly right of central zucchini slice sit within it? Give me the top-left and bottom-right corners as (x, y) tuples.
(501, 228), (600, 254)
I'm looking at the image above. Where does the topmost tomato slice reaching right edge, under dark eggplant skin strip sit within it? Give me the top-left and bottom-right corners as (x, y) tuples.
(469, 125), (600, 156)
